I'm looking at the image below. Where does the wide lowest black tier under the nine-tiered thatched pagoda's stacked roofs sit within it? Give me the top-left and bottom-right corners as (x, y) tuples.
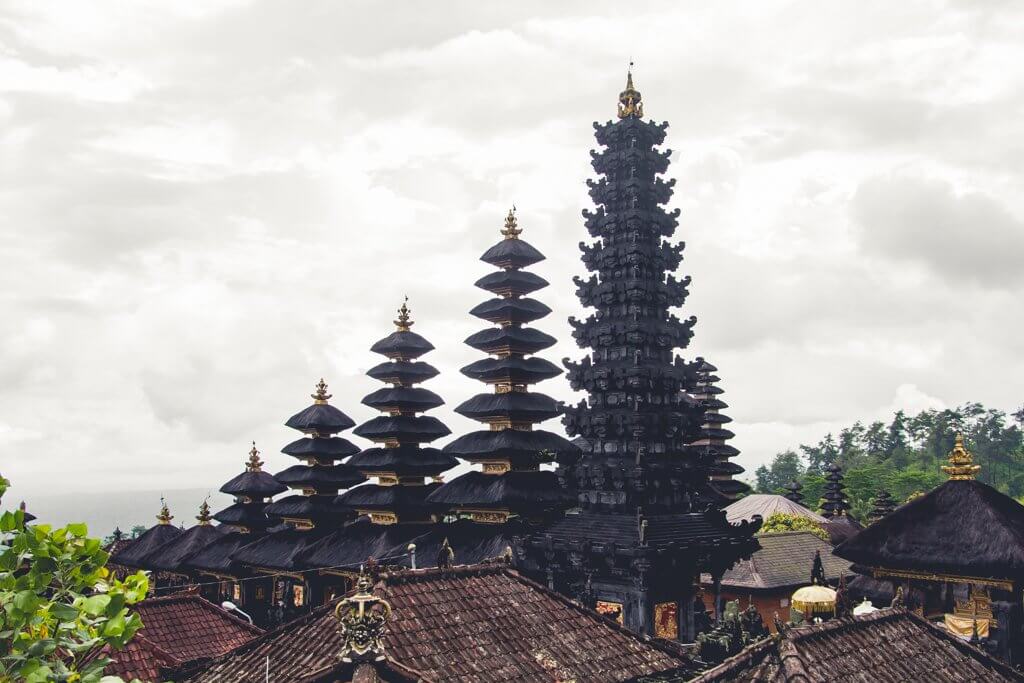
(427, 471), (574, 511)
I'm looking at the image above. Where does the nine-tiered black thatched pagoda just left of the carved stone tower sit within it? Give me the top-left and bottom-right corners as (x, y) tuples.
(429, 208), (580, 532)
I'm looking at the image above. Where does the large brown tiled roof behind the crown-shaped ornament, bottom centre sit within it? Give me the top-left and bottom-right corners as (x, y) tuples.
(187, 565), (689, 683)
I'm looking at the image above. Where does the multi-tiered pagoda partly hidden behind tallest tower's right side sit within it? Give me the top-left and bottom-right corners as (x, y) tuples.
(690, 356), (751, 505)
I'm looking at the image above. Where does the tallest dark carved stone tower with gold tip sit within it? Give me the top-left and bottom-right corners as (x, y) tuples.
(524, 74), (758, 640)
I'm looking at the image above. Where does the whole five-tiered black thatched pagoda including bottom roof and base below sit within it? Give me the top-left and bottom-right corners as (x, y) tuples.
(232, 379), (366, 618)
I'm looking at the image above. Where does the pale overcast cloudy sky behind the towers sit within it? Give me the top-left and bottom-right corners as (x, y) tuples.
(0, 0), (1024, 505)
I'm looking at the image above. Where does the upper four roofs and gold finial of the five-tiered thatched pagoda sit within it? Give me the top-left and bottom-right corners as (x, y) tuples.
(265, 379), (366, 529)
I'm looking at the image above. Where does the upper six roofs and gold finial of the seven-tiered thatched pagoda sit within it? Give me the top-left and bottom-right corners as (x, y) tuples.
(337, 297), (458, 524)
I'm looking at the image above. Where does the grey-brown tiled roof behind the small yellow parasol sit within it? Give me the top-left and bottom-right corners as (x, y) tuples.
(701, 531), (850, 590)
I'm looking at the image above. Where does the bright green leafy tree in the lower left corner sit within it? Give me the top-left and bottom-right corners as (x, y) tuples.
(0, 476), (148, 683)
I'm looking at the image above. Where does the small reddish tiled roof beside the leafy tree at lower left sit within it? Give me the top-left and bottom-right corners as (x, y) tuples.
(99, 593), (262, 681)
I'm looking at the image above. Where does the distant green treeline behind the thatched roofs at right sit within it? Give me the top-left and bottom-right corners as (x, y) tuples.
(755, 403), (1024, 518)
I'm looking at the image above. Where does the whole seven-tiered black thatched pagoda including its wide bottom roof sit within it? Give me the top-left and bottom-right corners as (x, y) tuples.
(302, 298), (459, 581)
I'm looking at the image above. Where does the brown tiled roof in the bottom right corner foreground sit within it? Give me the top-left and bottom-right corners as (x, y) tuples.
(693, 609), (1024, 683)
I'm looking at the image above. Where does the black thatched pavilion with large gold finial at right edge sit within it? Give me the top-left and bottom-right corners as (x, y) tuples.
(835, 435), (1024, 666)
